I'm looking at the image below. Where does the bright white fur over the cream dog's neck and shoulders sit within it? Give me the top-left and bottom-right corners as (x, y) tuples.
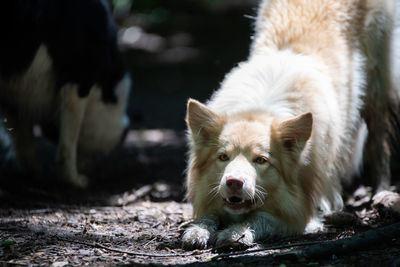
(208, 50), (348, 209)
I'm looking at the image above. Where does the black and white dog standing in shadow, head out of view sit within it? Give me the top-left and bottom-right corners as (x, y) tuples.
(0, 0), (130, 188)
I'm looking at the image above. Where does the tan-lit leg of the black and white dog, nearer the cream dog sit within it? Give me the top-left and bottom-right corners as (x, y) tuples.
(56, 84), (88, 188)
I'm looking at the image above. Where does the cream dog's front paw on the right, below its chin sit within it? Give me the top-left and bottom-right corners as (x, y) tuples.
(215, 225), (254, 248)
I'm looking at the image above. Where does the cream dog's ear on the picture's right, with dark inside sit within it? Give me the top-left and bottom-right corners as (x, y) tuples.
(278, 112), (313, 151)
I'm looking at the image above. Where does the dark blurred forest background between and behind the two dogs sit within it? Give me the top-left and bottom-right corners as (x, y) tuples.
(0, 0), (258, 205)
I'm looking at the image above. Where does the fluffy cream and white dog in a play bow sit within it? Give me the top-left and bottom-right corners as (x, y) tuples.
(182, 0), (399, 249)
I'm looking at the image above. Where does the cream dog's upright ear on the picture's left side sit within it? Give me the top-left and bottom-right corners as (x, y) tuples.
(186, 99), (223, 139)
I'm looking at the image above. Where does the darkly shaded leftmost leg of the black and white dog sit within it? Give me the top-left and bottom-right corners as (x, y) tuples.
(10, 119), (43, 179)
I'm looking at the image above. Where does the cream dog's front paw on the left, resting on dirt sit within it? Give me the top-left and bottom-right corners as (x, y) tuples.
(182, 225), (211, 249)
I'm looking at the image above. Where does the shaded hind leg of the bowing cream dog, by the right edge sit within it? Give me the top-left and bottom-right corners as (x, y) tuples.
(361, 0), (398, 191)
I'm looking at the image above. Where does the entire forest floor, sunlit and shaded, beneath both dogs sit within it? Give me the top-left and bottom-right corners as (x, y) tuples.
(0, 131), (400, 267)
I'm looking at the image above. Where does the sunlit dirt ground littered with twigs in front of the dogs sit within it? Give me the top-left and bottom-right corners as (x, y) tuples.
(0, 200), (400, 266)
